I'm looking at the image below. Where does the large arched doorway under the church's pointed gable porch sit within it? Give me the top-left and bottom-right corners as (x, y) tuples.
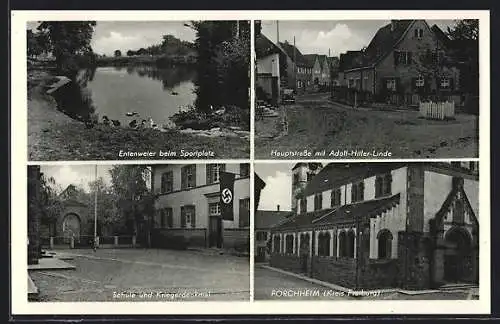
(444, 227), (475, 282)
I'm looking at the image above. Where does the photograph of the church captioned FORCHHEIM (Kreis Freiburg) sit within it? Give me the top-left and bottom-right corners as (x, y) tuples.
(254, 161), (480, 300)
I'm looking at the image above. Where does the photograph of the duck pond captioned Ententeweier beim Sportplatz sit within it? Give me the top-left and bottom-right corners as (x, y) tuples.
(26, 20), (250, 161)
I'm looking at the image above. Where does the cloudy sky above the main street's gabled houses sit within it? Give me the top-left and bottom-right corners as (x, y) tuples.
(262, 20), (454, 56)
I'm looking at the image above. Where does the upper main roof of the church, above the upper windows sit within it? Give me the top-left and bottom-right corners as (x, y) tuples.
(304, 162), (405, 196)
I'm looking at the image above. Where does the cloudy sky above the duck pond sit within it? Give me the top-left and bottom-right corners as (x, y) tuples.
(27, 21), (195, 55)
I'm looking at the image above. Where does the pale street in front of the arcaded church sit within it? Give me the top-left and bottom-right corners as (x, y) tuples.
(254, 265), (478, 300)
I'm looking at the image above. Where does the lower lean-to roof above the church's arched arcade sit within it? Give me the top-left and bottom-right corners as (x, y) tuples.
(274, 193), (400, 230)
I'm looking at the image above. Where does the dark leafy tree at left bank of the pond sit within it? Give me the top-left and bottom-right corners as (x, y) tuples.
(37, 21), (96, 74)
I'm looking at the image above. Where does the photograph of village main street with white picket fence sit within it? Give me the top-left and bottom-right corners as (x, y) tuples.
(255, 19), (479, 160)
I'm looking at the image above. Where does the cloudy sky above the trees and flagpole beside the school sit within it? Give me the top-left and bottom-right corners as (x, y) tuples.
(40, 165), (112, 191)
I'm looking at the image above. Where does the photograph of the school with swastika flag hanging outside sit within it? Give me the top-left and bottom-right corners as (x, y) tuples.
(27, 163), (250, 302)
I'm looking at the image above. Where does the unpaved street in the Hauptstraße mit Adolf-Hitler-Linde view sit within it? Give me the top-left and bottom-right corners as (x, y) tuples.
(255, 93), (478, 158)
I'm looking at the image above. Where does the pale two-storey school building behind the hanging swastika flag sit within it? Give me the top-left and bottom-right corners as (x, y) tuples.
(152, 163), (250, 251)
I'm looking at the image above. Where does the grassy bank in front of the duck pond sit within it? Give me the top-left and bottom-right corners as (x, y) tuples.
(28, 70), (250, 161)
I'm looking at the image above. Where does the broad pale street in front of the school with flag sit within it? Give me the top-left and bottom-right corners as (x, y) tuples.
(30, 249), (250, 301)
